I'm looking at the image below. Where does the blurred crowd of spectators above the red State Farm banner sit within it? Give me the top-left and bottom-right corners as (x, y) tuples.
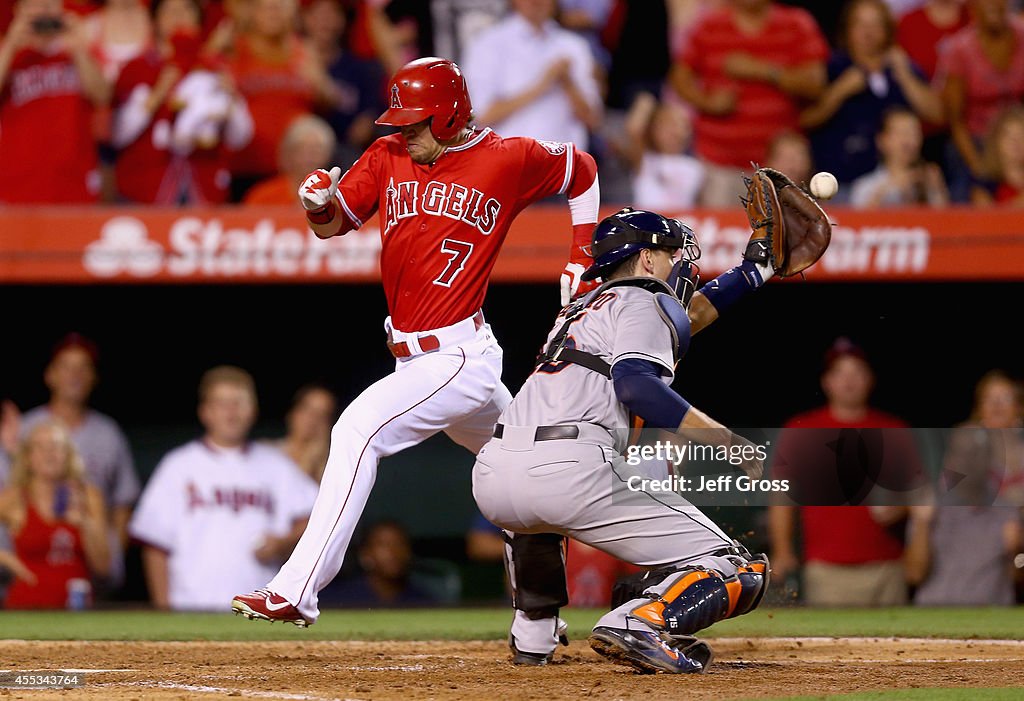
(0, 0), (1024, 210)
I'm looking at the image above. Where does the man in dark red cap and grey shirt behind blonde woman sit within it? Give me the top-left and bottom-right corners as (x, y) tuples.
(8, 334), (138, 584)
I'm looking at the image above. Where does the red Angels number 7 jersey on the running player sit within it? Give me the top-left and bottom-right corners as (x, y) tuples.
(338, 129), (579, 333)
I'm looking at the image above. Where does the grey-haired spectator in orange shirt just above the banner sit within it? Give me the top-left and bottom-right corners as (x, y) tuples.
(245, 115), (336, 207)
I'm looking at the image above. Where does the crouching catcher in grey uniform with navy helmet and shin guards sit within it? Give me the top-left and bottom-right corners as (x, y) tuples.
(473, 208), (773, 673)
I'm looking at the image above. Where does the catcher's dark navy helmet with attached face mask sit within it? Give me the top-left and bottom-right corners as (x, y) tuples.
(583, 207), (700, 305)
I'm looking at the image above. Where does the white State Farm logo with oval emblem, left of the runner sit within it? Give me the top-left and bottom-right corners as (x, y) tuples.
(82, 217), (380, 278)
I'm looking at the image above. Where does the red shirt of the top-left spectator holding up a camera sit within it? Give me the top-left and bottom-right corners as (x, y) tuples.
(0, 49), (99, 204)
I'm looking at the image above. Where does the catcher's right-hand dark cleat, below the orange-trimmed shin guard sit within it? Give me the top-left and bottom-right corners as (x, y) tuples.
(590, 625), (715, 674)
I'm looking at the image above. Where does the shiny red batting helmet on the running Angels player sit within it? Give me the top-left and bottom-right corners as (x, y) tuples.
(377, 56), (473, 141)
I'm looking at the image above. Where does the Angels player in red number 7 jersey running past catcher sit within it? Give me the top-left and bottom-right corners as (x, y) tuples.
(231, 58), (600, 626)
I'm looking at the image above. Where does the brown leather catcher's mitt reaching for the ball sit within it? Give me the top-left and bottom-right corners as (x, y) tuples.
(743, 168), (831, 277)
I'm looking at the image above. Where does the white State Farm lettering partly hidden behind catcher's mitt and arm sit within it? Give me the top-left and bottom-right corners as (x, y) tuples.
(682, 216), (931, 275)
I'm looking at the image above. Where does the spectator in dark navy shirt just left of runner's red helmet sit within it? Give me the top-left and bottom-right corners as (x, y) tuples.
(302, 0), (386, 164)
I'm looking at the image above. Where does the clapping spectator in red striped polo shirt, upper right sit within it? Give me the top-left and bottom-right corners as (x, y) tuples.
(671, 0), (828, 207)
